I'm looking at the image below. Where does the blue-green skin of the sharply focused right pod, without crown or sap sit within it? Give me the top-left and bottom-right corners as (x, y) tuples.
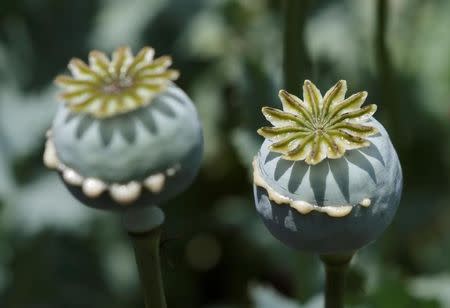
(254, 118), (402, 254)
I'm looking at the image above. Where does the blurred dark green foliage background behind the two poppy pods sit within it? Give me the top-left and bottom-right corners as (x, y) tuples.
(0, 0), (450, 308)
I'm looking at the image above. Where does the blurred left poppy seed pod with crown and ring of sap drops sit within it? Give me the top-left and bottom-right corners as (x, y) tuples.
(44, 47), (203, 209)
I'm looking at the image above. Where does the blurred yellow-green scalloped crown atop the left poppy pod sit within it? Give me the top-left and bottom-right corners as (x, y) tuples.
(55, 47), (179, 118)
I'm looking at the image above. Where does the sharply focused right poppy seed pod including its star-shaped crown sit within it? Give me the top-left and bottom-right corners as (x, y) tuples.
(253, 80), (402, 254)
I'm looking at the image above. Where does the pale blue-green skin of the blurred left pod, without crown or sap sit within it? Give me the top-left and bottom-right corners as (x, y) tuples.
(52, 84), (203, 208)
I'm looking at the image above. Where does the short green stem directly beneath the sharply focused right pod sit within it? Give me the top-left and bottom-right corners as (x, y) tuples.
(320, 254), (353, 308)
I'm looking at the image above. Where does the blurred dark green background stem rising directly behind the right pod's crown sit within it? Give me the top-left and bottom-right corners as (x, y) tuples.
(283, 0), (311, 93)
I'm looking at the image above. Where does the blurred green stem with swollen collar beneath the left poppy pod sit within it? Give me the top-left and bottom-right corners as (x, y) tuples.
(122, 206), (167, 308)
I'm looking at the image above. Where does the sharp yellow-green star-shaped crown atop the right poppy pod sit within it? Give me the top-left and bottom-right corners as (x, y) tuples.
(258, 80), (378, 165)
